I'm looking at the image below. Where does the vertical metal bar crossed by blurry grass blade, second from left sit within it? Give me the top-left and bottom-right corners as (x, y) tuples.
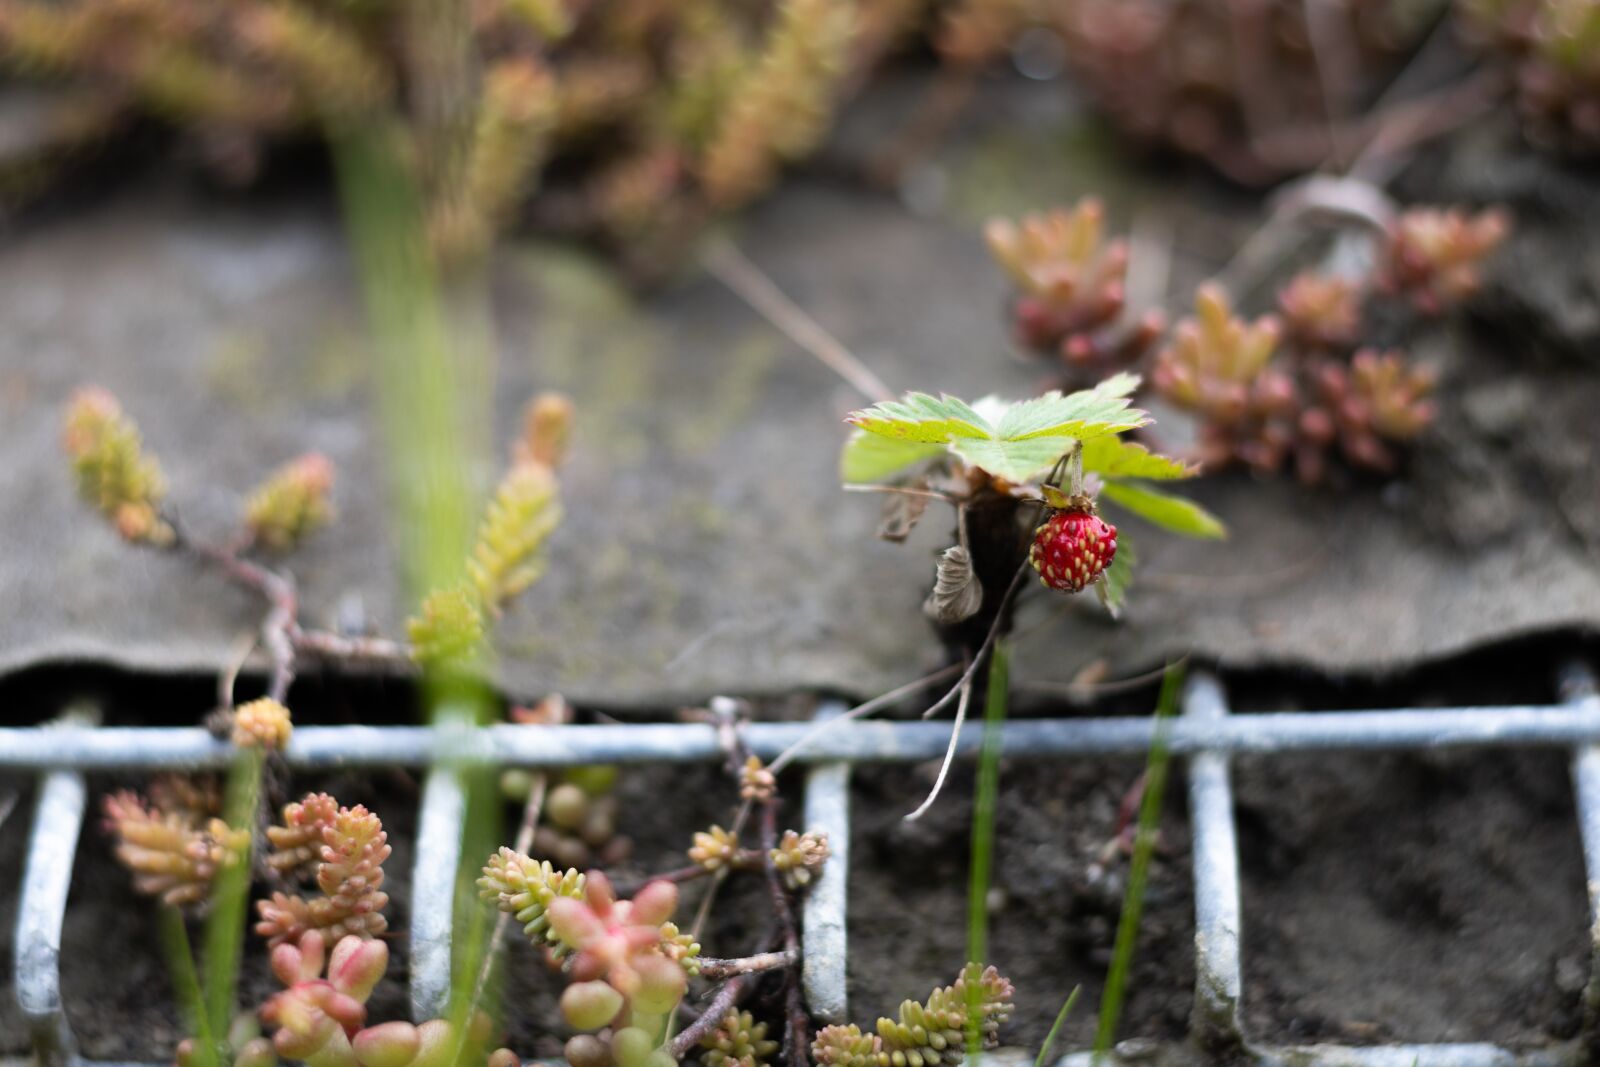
(411, 765), (467, 1022)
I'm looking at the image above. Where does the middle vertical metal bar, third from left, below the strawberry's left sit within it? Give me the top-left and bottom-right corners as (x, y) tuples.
(800, 702), (850, 1022)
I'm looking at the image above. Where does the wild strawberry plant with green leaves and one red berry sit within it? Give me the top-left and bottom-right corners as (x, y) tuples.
(840, 374), (1224, 627)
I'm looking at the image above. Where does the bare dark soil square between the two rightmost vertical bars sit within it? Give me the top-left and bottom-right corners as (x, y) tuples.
(1235, 752), (1587, 1046)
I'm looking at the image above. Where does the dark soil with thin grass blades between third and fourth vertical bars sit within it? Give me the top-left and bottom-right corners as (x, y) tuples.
(850, 760), (1194, 1049)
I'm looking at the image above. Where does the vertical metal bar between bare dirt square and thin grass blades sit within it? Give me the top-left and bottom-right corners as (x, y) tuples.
(1179, 675), (1245, 1048)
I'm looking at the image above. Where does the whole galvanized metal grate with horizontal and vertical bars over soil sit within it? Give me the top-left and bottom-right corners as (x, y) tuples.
(0, 664), (1600, 1067)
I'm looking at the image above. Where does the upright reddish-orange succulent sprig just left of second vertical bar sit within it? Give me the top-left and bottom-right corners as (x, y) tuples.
(256, 793), (390, 945)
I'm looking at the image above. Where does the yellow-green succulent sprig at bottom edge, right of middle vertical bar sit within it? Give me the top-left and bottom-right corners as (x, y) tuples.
(811, 963), (1014, 1067)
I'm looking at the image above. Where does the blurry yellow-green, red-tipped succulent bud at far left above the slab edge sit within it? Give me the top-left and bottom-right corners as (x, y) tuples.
(61, 386), (173, 545)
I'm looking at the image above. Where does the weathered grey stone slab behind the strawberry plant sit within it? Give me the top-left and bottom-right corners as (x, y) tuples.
(0, 91), (1600, 704)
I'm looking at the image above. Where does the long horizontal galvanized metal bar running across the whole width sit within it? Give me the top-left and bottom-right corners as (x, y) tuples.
(15, 697), (1600, 771)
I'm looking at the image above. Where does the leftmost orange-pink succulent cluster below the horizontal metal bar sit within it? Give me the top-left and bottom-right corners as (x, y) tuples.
(104, 779), (250, 907)
